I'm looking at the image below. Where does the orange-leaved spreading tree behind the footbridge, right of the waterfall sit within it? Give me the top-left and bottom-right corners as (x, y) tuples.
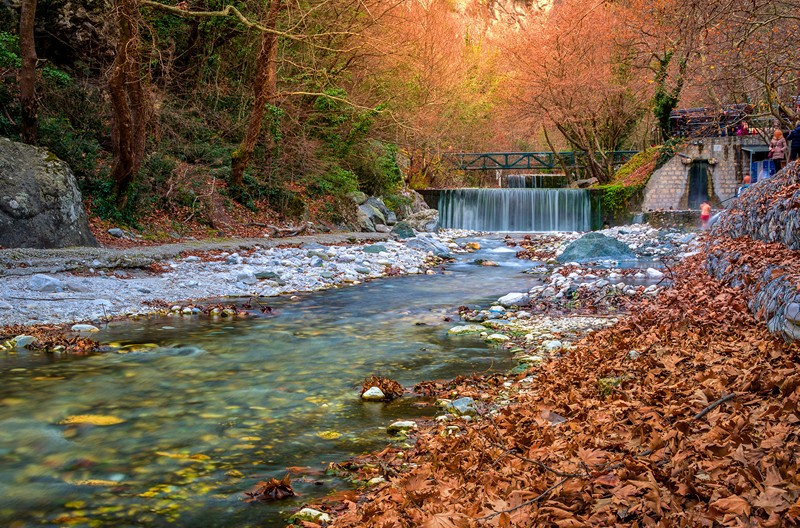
(512, 2), (646, 182)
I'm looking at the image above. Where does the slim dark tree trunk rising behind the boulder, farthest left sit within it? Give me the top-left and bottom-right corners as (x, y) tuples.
(19, 0), (39, 145)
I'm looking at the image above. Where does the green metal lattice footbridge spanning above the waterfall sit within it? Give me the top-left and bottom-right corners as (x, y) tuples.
(442, 150), (639, 170)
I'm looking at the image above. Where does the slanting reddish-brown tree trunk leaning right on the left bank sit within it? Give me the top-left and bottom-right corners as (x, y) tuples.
(230, 0), (281, 193)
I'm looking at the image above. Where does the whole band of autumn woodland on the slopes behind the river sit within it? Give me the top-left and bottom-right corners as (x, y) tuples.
(0, 0), (800, 227)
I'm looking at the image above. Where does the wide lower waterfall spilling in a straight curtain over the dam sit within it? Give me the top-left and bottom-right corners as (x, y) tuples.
(439, 189), (591, 231)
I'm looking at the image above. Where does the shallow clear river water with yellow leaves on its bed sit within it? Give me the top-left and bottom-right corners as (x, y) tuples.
(0, 239), (536, 527)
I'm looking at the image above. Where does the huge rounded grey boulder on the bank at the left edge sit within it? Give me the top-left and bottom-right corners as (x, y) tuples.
(0, 138), (98, 248)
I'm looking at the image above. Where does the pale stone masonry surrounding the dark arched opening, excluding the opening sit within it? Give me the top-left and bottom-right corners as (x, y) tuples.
(642, 136), (764, 212)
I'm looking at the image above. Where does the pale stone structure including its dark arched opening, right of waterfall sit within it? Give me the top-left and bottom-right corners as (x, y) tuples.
(642, 135), (768, 212)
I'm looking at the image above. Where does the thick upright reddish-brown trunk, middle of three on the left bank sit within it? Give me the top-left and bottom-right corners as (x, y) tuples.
(108, 0), (147, 208)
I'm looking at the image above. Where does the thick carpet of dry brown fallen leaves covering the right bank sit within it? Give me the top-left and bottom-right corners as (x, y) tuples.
(318, 249), (800, 528)
